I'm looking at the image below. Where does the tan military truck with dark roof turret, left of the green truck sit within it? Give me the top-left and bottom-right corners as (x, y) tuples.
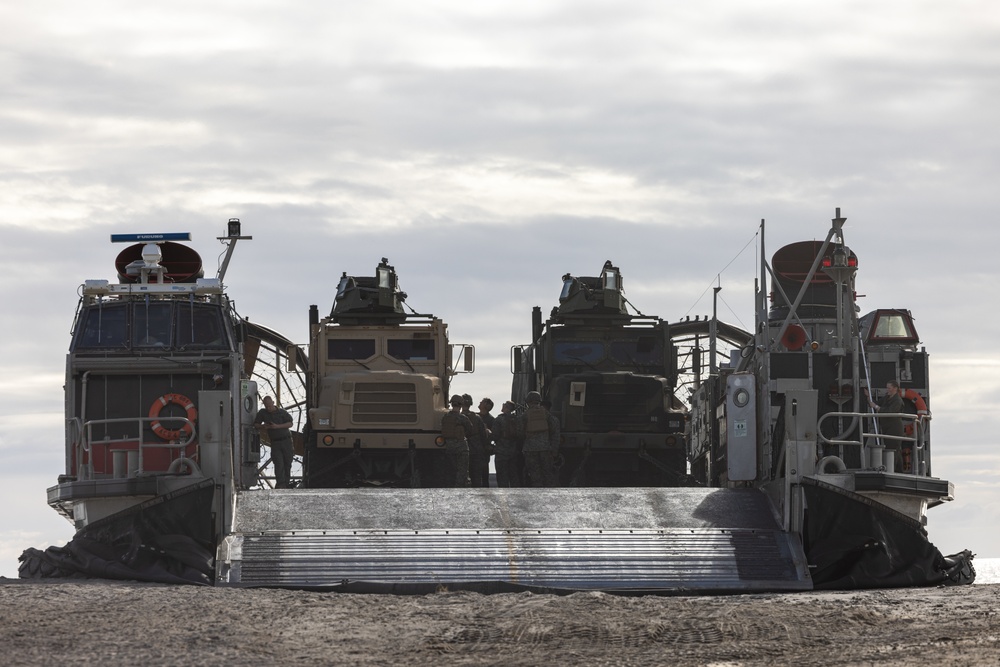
(303, 258), (475, 488)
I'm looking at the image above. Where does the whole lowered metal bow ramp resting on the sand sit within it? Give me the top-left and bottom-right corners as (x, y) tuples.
(217, 488), (812, 593)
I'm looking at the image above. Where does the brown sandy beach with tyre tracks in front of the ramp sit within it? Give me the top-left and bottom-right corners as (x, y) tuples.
(0, 578), (1000, 667)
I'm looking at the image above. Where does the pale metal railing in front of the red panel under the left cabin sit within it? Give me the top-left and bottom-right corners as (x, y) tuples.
(69, 417), (201, 480)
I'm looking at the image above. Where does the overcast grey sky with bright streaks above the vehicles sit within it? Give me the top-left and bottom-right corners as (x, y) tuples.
(0, 0), (1000, 576)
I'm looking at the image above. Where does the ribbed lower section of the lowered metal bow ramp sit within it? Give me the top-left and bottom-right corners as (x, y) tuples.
(229, 529), (809, 591)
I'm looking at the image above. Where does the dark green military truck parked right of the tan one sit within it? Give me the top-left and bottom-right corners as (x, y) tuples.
(512, 261), (687, 486)
